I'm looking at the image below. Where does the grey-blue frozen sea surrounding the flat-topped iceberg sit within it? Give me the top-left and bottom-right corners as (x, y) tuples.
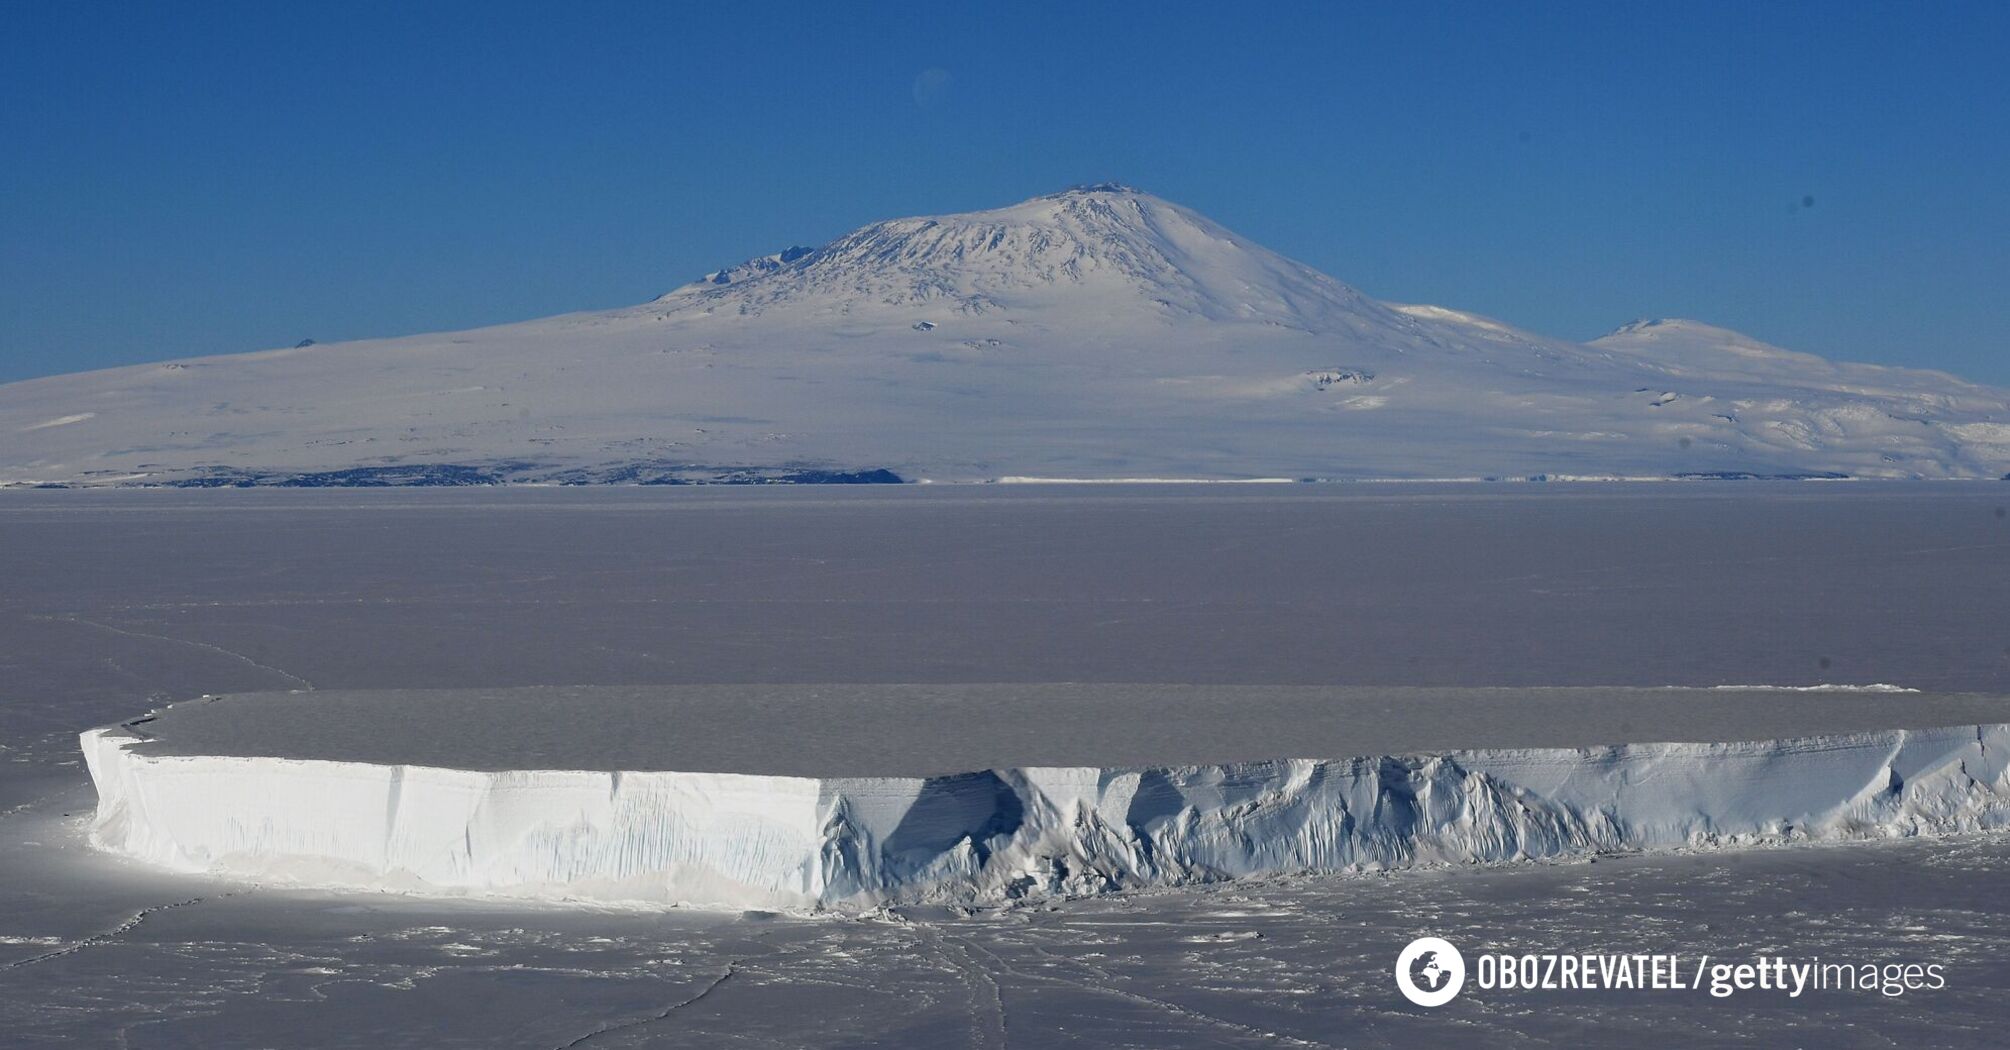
(0, 483), (2010, 1048)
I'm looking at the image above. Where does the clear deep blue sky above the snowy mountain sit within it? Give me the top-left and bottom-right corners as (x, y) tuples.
(0, 0), (2010, 384)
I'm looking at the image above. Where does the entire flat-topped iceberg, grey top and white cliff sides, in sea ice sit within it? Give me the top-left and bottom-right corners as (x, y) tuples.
(82, 686), (2010, 911)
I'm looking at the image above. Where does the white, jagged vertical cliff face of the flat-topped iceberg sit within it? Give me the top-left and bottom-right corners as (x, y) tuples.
(82, 724), (2010, 911)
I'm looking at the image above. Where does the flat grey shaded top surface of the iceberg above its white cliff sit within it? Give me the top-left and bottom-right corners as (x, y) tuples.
(114, 684), (2010, 778)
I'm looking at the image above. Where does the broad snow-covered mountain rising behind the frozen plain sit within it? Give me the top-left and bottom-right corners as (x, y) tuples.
(0, 185), (2010, 485)
